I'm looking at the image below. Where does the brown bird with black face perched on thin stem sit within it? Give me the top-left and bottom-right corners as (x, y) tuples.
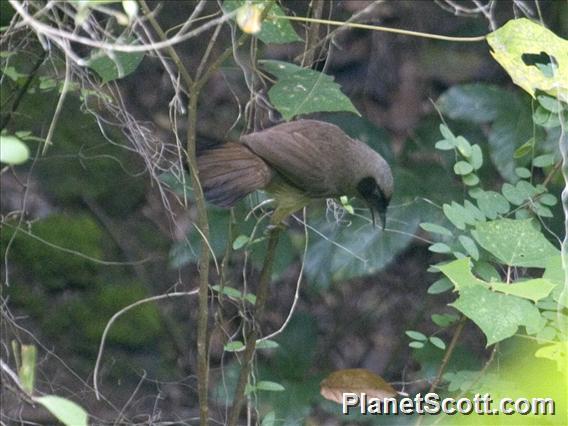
(197, 119), (394, 229)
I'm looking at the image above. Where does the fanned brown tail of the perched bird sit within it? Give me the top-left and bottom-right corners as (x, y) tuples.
(197, 142), (272, 207)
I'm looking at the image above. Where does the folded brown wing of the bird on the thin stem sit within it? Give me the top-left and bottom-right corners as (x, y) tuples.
(241, 120), (337, 198)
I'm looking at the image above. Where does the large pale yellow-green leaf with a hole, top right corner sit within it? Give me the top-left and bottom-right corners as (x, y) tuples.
(487, 18), (568, 102)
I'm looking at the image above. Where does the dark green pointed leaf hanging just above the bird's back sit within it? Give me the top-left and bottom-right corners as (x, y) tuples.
(259, 60), (360, 121)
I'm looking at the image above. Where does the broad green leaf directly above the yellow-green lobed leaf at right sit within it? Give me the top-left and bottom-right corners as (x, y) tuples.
(472, 219), (558, 268)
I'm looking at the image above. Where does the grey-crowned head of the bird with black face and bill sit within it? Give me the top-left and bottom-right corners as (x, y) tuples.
(357, 154), (393, 229)
